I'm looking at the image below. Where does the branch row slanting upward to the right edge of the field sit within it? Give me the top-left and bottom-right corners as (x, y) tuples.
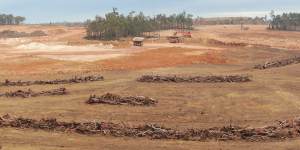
(254, 56), (300, 70)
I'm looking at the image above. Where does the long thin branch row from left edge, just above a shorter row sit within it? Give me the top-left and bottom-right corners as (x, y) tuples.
(0, 76), (104, 86)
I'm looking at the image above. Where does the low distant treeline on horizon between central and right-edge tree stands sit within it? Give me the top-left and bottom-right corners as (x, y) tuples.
(194, 17), (267, 25)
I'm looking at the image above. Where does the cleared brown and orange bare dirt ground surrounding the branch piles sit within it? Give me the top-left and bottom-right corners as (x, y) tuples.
(0, 26), (300, 150)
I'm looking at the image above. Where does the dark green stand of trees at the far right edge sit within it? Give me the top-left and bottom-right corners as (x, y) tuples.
(269, 11), (300, 31)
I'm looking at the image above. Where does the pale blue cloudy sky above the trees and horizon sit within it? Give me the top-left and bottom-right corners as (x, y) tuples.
(0, 0), (300, 23)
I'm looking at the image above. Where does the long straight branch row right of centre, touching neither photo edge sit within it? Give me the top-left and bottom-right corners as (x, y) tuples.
(137, 75), (251, 83)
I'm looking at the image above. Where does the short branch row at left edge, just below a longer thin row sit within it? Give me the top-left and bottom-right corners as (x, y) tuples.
(0, 88), (67, 98)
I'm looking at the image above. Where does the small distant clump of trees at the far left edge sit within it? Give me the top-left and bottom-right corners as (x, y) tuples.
(0, 14), (26, 25)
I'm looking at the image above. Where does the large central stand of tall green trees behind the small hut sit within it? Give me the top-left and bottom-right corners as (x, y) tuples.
(87, 9), (193, 40)
